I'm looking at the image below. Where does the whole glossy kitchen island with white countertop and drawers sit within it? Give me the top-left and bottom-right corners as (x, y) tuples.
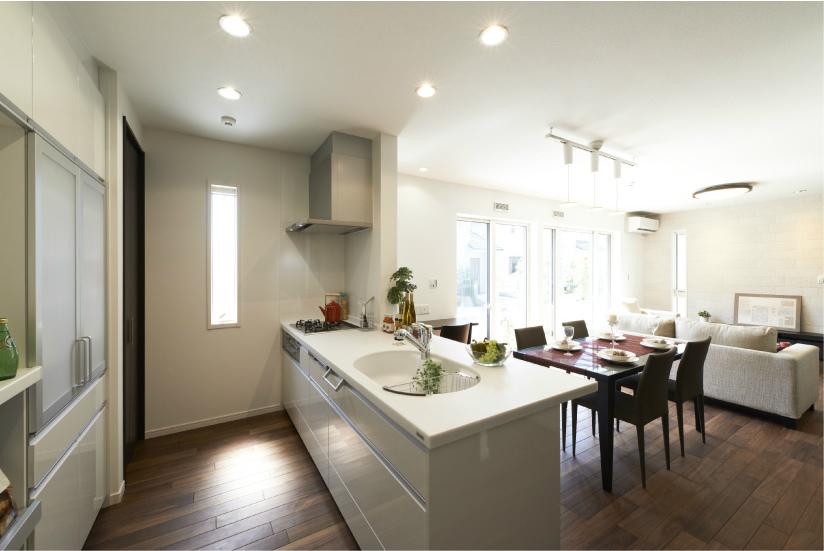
(282, 322), (596, 549)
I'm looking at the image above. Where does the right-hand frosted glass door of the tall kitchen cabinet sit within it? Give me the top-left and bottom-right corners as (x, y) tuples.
(79, 173), (106, 382)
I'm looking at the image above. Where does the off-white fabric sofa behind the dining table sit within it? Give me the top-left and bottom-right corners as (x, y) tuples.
(618, 313), (819, 425)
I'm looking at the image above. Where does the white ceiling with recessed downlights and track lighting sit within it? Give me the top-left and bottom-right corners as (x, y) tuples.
(67, 2), (824, 212)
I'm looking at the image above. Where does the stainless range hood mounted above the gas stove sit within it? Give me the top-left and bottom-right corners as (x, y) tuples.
(286, 132), (372, 235)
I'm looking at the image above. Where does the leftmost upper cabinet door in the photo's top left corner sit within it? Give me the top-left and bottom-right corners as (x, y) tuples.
(0, 2), (34, 116)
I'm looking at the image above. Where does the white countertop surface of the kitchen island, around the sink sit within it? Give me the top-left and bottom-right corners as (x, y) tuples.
(281, 321), (597, 449)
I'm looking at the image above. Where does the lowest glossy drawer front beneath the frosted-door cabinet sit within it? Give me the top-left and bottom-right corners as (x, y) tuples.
(31, 406), (106, 549)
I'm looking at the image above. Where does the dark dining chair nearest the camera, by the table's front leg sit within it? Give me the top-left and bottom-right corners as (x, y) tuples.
(615, 348), (675, 488)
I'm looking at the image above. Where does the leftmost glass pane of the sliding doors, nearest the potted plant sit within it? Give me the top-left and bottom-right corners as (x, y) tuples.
(456, 220), (489, 339)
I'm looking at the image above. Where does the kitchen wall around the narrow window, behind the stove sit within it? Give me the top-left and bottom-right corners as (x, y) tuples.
(144, 129), (343, 436)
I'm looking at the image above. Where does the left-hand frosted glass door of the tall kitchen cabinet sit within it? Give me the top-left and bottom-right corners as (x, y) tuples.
(32, 138), (81, 430)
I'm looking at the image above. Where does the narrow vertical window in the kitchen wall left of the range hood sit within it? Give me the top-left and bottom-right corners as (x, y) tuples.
(208, 184), (239, 329)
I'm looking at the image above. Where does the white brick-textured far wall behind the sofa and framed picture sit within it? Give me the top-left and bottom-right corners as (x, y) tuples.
(642, 194), (824, 332)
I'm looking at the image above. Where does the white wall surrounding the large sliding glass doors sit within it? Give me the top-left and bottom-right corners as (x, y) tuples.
(398, 174), (641, 334)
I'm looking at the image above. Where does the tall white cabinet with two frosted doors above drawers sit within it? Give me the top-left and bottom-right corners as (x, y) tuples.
(26, 134), (106, 549)
